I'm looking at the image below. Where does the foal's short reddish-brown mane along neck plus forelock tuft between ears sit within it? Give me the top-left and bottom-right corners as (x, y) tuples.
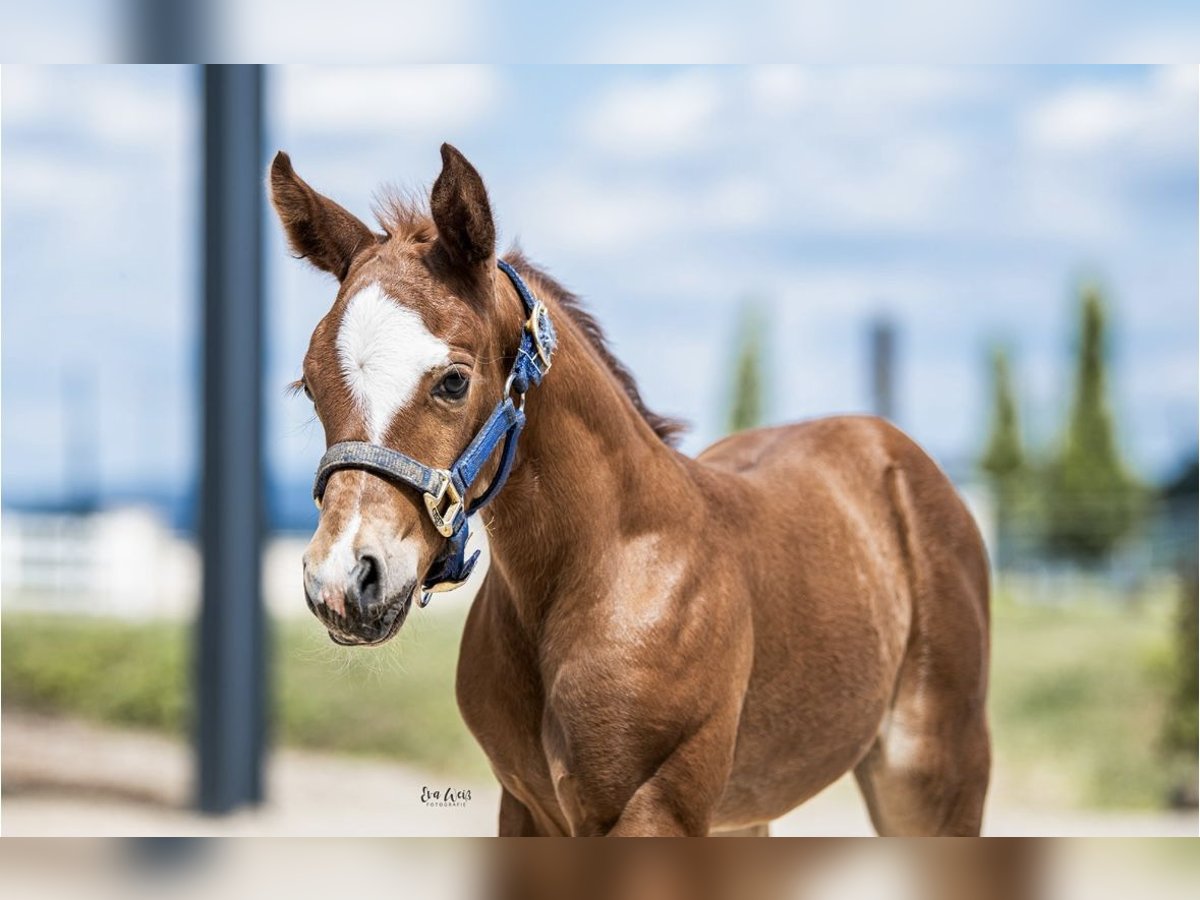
(374, 188), (688, 446)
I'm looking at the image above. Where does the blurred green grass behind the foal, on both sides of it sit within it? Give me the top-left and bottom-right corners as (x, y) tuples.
(2, 578), (1171, 809)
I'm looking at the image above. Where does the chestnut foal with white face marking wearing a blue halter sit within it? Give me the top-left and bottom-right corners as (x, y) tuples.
(270, 145), (990, 835)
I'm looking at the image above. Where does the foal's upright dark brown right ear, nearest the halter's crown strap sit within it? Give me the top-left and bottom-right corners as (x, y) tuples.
(430, 144), (496, 268)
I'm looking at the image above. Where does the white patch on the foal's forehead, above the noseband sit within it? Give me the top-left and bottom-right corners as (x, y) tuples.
(337, 284), (450, 444)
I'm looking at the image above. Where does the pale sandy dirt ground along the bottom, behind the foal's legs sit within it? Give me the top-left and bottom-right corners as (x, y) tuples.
(0, 710), (1198, 836)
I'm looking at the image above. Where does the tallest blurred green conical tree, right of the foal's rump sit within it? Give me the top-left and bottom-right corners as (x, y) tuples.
(1044, 286), (1142, 563)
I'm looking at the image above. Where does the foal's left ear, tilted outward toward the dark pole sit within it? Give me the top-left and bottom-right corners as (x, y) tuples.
(269, 150), (376, 281)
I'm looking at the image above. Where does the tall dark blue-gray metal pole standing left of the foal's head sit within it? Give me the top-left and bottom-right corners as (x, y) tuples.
(197, 66), (266, 812)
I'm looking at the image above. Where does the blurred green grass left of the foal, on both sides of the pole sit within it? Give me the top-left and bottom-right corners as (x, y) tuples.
(0, 613), (488, 778)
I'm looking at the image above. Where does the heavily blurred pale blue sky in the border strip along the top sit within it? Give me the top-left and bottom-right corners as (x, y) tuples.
(7, 0), (1200, 64)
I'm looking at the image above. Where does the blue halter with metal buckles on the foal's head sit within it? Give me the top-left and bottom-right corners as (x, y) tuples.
(312, 259), (557, 606)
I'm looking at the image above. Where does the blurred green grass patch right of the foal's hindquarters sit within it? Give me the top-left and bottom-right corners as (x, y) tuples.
(990, 580), (1171, 809)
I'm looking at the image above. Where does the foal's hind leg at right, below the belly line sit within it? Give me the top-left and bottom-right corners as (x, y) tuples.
(854, 695), (991, 836)
